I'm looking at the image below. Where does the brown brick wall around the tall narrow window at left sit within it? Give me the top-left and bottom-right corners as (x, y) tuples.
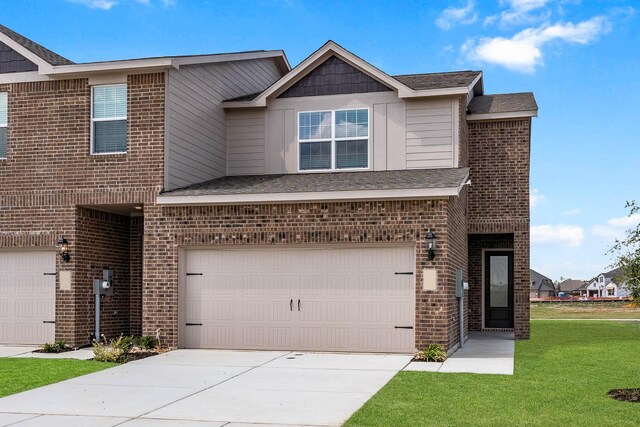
(0, 73), (165, 344)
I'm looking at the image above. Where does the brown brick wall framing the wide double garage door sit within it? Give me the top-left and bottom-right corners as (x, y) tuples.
(143, 199), (466, 348)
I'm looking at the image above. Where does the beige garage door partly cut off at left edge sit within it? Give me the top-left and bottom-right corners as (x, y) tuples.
(0, 251), (56, 344)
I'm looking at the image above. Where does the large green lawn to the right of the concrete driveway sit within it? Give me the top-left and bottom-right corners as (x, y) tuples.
(346, 320), (640, 427)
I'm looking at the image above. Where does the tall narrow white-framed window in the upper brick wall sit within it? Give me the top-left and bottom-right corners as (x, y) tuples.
(91, 84), (127, 154)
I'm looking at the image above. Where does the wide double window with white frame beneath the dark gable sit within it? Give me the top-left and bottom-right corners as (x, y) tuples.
(298, 109), (369, 171)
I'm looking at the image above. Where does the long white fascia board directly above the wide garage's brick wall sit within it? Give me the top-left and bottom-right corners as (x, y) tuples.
(156, 184), (464, 206)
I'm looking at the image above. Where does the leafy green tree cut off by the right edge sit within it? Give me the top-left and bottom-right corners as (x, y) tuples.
(608, 200), (640, 307)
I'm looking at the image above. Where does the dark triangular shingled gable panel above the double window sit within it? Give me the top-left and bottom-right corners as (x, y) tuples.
(279, 55), (393, 98)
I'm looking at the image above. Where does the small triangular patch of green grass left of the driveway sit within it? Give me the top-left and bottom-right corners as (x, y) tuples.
(0, 357), (116, 397)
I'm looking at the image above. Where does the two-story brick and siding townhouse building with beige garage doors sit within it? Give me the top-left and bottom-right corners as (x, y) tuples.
(0, 27), (537, 352)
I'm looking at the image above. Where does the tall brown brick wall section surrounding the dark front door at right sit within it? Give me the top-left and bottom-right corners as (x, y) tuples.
(468, 118), (531, 339)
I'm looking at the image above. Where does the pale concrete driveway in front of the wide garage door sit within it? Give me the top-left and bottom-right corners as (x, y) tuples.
(0, 350), (411, 427)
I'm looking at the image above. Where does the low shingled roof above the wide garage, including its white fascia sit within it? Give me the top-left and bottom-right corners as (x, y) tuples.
(158, 168), (469, 204)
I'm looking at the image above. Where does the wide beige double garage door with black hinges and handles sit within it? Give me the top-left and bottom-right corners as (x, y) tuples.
(185, 247), (415, 352)
